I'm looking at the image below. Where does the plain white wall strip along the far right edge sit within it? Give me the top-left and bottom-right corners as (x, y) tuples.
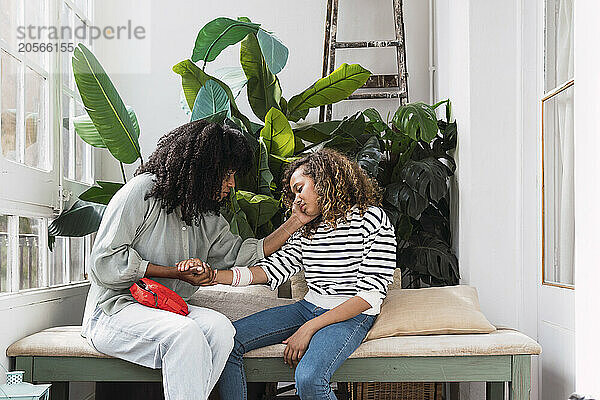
(575, 0), (600, 399)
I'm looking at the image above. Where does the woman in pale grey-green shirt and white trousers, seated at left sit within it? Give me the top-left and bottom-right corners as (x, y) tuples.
(82, 121), (310, 400)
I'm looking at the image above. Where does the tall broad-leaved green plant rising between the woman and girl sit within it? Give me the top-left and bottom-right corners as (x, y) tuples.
(173, 17), (371, 237)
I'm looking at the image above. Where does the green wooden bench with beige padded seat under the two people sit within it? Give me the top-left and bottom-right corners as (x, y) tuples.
(7, 292), (541, 400)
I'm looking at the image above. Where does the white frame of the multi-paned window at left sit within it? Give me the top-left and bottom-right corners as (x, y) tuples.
(0, 0), (100, 299)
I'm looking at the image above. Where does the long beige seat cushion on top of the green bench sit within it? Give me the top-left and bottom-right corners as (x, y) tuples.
(6, 290), (541, 358)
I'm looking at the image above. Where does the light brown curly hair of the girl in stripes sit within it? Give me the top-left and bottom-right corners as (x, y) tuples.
(282, 149), (381, 237)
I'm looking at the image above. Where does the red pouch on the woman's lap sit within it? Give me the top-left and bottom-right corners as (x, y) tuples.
(129, 278), (190, 315)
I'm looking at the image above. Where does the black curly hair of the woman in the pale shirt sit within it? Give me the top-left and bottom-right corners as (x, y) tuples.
(135, 120), (252, 225)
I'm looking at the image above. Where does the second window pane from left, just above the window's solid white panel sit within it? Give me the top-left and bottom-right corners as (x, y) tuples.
(25, 68), (49, 169)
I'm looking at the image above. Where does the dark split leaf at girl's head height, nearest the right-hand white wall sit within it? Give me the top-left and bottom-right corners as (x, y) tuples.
(400, 158), (452, 202)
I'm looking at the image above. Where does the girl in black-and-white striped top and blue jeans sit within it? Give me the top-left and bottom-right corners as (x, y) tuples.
(187, 150), (396, 400)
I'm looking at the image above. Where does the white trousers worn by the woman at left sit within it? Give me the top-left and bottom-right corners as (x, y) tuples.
(84, 303), (235, 400)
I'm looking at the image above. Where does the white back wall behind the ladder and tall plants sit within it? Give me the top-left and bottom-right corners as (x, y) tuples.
(95, 0), (429, 180)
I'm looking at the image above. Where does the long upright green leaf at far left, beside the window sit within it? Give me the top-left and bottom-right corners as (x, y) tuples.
(72, 43), (141, 164)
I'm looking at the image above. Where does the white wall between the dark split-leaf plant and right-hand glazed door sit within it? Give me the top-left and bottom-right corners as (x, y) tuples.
(434, 0), (540, 399)
